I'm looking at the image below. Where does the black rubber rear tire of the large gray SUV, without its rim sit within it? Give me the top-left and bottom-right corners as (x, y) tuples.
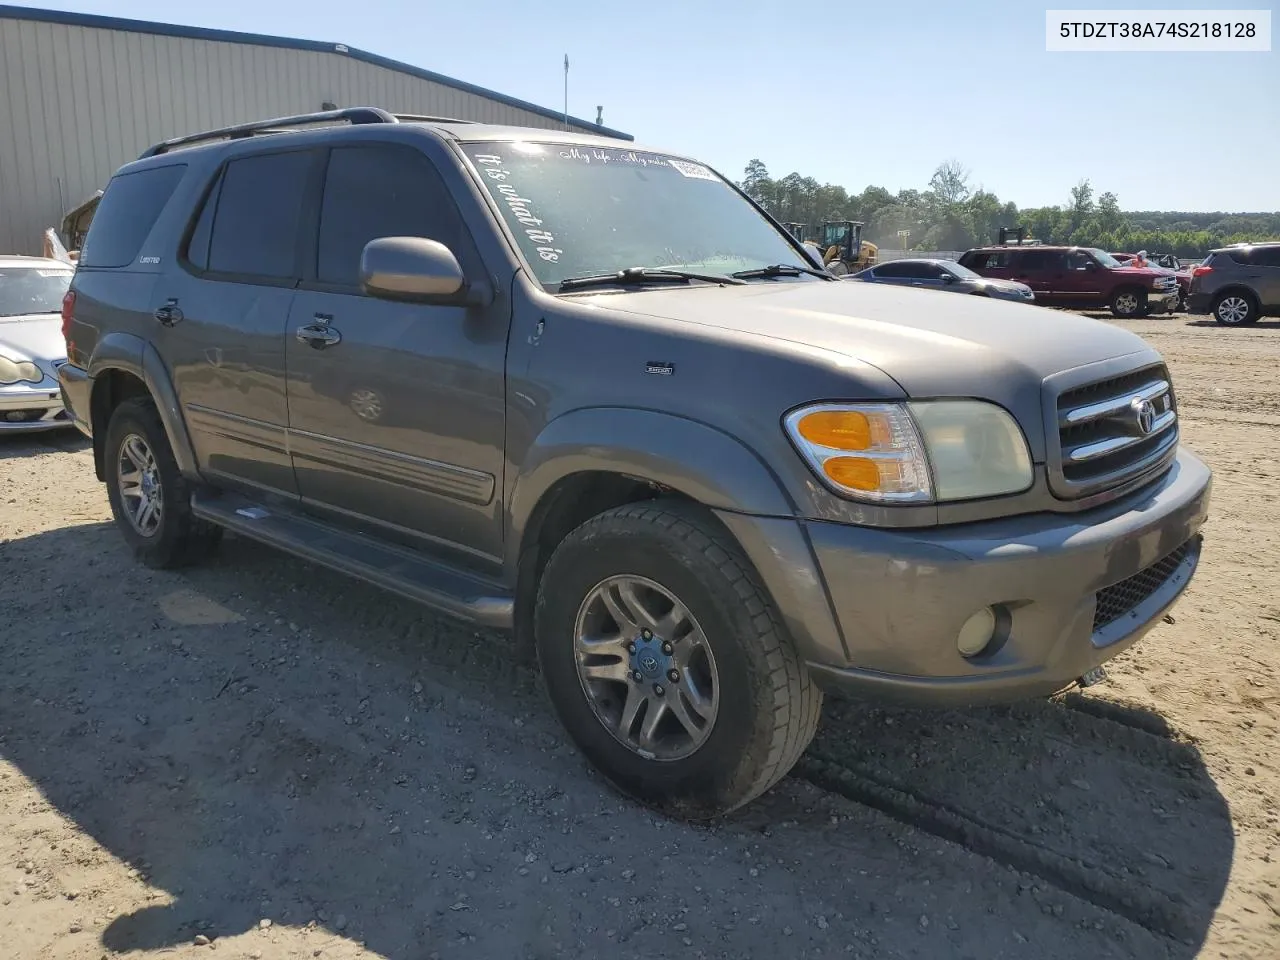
(104, 397), (223, 570)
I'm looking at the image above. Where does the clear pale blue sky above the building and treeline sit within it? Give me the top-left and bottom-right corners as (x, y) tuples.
(10, 0), (1280, 211)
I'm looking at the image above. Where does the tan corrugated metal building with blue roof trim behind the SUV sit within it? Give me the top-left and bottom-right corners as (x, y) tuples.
(0, 5), (632, 253)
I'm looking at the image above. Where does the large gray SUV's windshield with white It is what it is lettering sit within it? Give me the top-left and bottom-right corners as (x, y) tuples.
(462, 141), (808, 288)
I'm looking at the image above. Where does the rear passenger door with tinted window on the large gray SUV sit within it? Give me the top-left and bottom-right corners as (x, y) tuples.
(151, 148), (323, 495)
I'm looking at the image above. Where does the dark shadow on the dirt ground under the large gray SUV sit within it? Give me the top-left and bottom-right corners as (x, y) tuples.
(0, 524), (1233, 960)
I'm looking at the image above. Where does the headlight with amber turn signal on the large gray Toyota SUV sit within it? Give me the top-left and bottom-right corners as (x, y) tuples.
(783, 399), (1032, 503)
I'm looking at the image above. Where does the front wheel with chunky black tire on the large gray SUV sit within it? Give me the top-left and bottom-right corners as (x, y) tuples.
(535, 500), (822, 820)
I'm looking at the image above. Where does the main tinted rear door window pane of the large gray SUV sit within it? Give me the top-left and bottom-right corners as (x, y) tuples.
(207, 151), (314, 279)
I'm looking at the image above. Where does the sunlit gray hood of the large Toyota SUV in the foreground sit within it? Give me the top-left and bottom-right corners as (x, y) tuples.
(588, 280), (1151, 406)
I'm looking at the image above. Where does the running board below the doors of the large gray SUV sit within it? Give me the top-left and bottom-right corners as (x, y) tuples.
(191, 492), (515, 630)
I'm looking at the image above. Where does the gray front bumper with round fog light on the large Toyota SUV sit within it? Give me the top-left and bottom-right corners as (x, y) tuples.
(801, 451), (1212, 705)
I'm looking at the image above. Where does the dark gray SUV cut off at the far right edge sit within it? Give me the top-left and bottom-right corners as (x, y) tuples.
(1188, 243), (1280, 326)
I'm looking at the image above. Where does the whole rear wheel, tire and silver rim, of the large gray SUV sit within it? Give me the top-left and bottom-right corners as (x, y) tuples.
(104, 397), (223, 570)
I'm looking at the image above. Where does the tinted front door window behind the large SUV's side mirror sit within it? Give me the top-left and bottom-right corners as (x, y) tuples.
(316, 145), (471, 287)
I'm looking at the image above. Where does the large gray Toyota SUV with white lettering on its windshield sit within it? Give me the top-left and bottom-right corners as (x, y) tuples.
(60, 108), (1211, 818)
